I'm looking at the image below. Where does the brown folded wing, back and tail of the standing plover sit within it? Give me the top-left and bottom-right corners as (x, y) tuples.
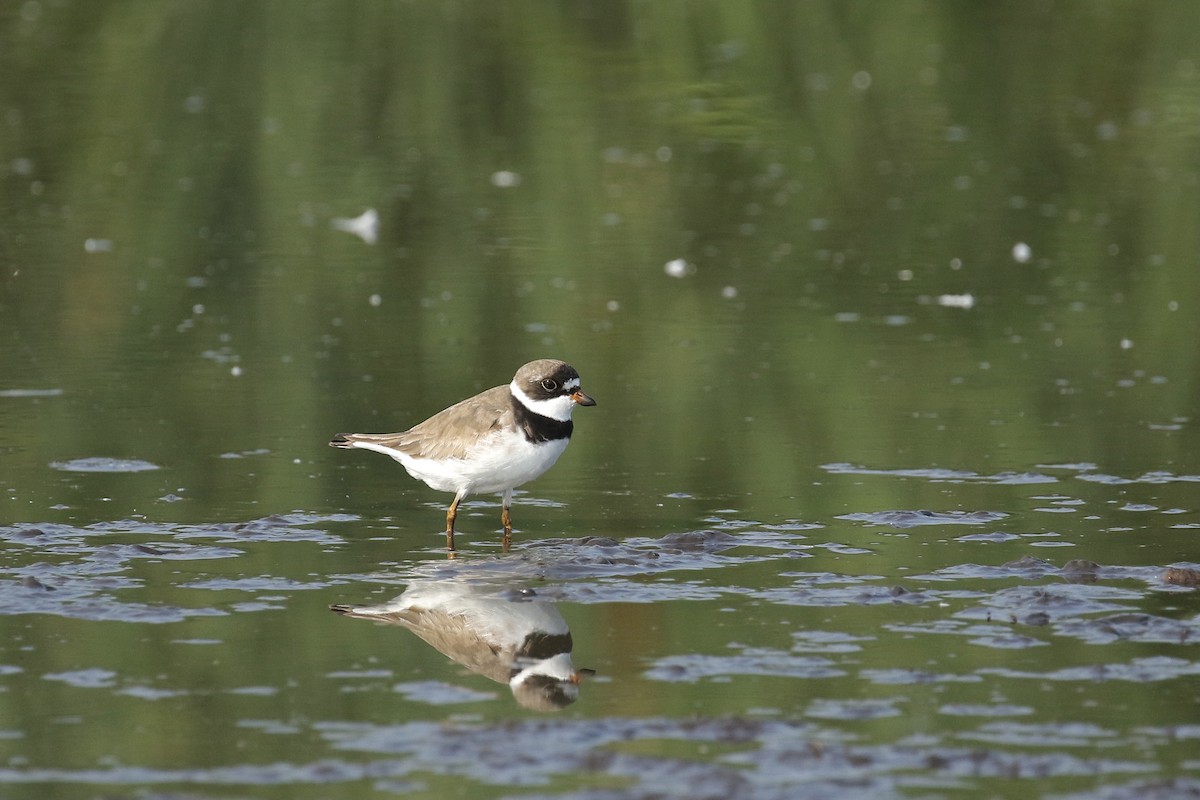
(340, 386), (512, 458)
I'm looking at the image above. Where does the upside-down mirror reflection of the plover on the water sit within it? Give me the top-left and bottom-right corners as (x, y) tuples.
(329, 581), (595, 711)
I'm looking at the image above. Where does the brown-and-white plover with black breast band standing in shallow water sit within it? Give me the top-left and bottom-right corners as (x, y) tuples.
(329, 359), (596, 553)
